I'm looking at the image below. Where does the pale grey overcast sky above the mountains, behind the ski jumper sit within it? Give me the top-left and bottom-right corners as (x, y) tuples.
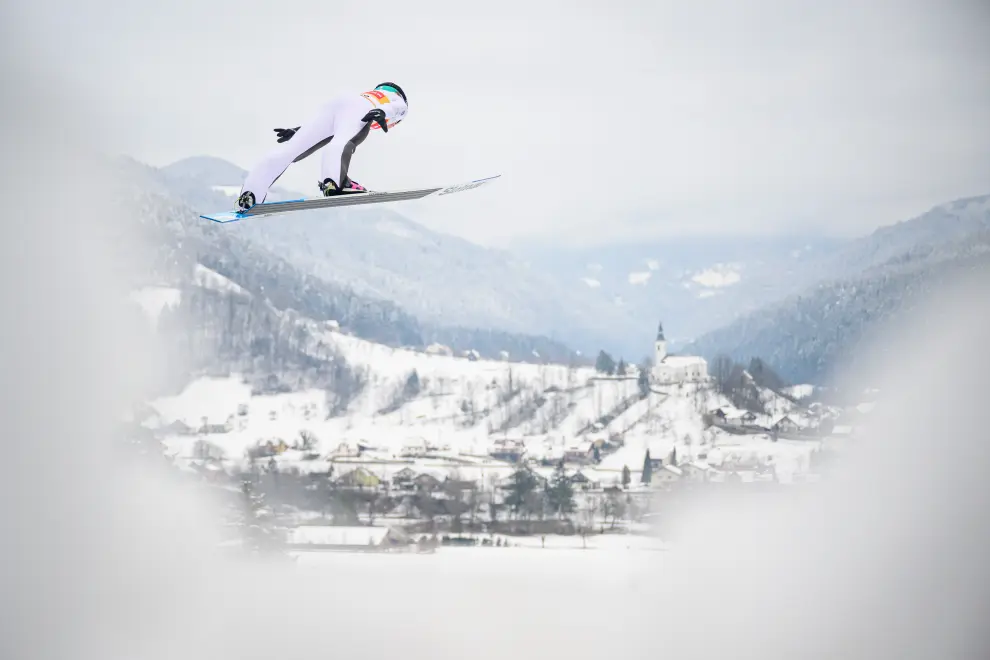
(5, 0), (990, 248)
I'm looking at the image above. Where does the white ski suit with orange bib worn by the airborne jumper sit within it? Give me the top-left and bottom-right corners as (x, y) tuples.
(241, 89), (408, 204)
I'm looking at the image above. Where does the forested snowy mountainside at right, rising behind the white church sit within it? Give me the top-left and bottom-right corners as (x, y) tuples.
(689, 196), (990, 383)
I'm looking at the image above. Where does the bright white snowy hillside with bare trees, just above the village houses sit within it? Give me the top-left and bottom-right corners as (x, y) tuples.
(145, 310), (812, 482)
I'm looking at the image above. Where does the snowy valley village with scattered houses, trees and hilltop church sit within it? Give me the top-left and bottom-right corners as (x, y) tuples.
(134, 326), (873, 552)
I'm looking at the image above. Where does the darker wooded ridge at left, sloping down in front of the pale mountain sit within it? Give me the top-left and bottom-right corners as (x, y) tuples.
(112, 153), (579, 369)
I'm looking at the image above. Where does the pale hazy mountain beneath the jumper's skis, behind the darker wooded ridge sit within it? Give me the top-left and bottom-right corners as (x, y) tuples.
(162, 157), (644, 354)
